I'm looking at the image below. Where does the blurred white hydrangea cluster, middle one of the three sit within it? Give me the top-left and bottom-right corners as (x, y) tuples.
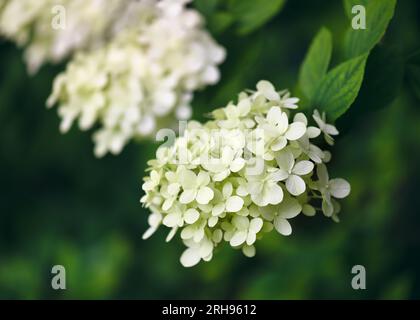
(48, 0), (225, 157)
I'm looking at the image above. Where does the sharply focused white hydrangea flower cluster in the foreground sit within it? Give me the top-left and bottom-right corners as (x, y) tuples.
(140, 81), (350, 267)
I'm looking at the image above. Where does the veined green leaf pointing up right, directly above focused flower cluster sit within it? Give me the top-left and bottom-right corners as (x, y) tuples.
(313, 54), (367, 119)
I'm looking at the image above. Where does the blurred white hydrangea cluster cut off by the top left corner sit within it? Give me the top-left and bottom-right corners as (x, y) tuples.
(0, 0), (127, 74)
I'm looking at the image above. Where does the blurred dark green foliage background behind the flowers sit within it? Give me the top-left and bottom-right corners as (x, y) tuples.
(0, 0), (420, 299)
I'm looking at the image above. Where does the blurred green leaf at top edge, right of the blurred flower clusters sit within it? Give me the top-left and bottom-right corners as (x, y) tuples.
(229, 0), (285, 35)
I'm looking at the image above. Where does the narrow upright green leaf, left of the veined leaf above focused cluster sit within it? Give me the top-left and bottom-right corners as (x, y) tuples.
(299, 28), (332, 101)
